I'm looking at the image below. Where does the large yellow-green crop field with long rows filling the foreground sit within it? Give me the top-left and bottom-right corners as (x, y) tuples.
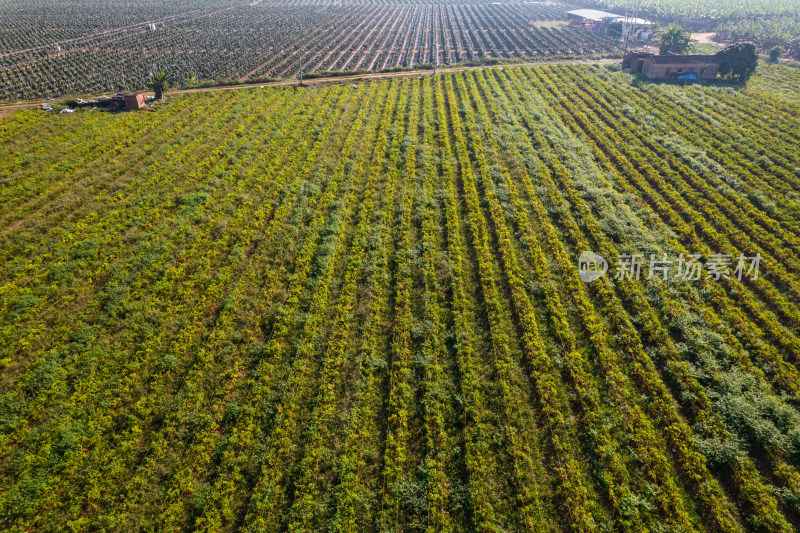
(0, 64), (800, 532)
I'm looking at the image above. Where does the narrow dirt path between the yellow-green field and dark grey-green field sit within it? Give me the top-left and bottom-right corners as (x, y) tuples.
(0, 59), (620, 115)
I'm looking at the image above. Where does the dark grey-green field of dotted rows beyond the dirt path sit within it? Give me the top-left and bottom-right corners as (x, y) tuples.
(0, 0), (619, 100)
